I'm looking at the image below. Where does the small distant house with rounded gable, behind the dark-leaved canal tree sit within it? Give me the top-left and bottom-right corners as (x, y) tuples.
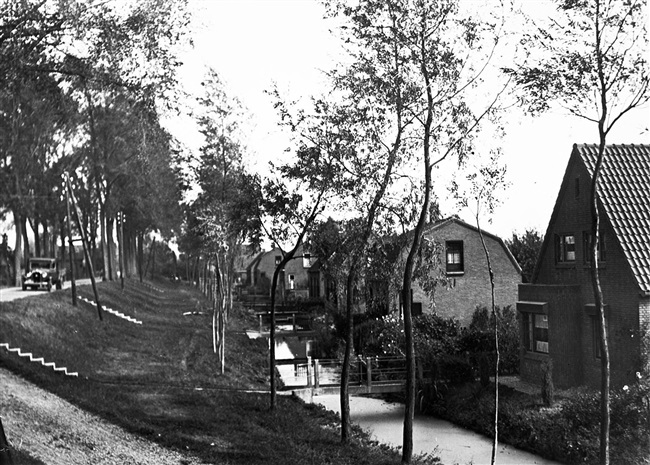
(252, 245), (312, 298)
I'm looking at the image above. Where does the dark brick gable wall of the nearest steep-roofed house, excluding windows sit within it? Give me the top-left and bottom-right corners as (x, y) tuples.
(519, 152), (640, 387)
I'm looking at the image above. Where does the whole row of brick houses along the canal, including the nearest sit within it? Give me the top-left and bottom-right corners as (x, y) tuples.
(238, 144), (650, 388)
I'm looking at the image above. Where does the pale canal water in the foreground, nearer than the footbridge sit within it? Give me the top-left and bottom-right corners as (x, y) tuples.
(314, 395), (560, 465)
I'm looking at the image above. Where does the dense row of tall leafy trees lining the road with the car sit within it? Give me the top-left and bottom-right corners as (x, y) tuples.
(0, 0), (189, 280)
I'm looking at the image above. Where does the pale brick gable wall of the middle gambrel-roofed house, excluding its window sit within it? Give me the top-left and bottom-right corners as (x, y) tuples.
(413, 222), (521, 325)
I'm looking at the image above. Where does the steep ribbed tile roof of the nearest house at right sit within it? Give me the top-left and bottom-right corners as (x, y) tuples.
(574, 144), (650, 293)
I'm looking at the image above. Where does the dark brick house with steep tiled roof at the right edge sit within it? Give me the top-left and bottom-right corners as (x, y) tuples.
(517, 144), (650, 388)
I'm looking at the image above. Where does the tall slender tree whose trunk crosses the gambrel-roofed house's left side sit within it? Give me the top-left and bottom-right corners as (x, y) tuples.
(324, 1), (500, 463)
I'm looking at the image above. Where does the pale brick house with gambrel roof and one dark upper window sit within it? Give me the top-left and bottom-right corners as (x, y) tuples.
(390, 217), (521, 326)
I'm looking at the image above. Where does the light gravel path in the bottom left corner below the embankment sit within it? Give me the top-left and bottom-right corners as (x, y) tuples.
(0, 368), (202, 465)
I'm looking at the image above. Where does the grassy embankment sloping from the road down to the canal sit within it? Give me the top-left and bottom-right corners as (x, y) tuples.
(0, 281), (430, 464)
